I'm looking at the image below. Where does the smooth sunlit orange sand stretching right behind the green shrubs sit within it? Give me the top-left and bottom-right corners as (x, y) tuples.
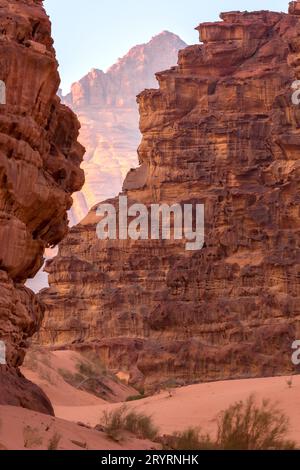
(55, 376), (300, 444)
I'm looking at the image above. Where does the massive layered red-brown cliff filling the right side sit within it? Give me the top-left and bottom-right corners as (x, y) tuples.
(39, 2), (300, 388)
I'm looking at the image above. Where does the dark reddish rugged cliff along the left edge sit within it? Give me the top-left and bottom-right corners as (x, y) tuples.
(0, 0), (84, 411)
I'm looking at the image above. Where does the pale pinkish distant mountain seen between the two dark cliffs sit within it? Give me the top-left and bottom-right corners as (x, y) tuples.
(63, 31), (186, 225)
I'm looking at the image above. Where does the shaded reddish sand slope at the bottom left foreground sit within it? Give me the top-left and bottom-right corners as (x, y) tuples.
(0, 406), (159, 450)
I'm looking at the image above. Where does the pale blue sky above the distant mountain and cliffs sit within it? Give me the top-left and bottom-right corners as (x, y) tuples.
(44, 0), (289, 94)
